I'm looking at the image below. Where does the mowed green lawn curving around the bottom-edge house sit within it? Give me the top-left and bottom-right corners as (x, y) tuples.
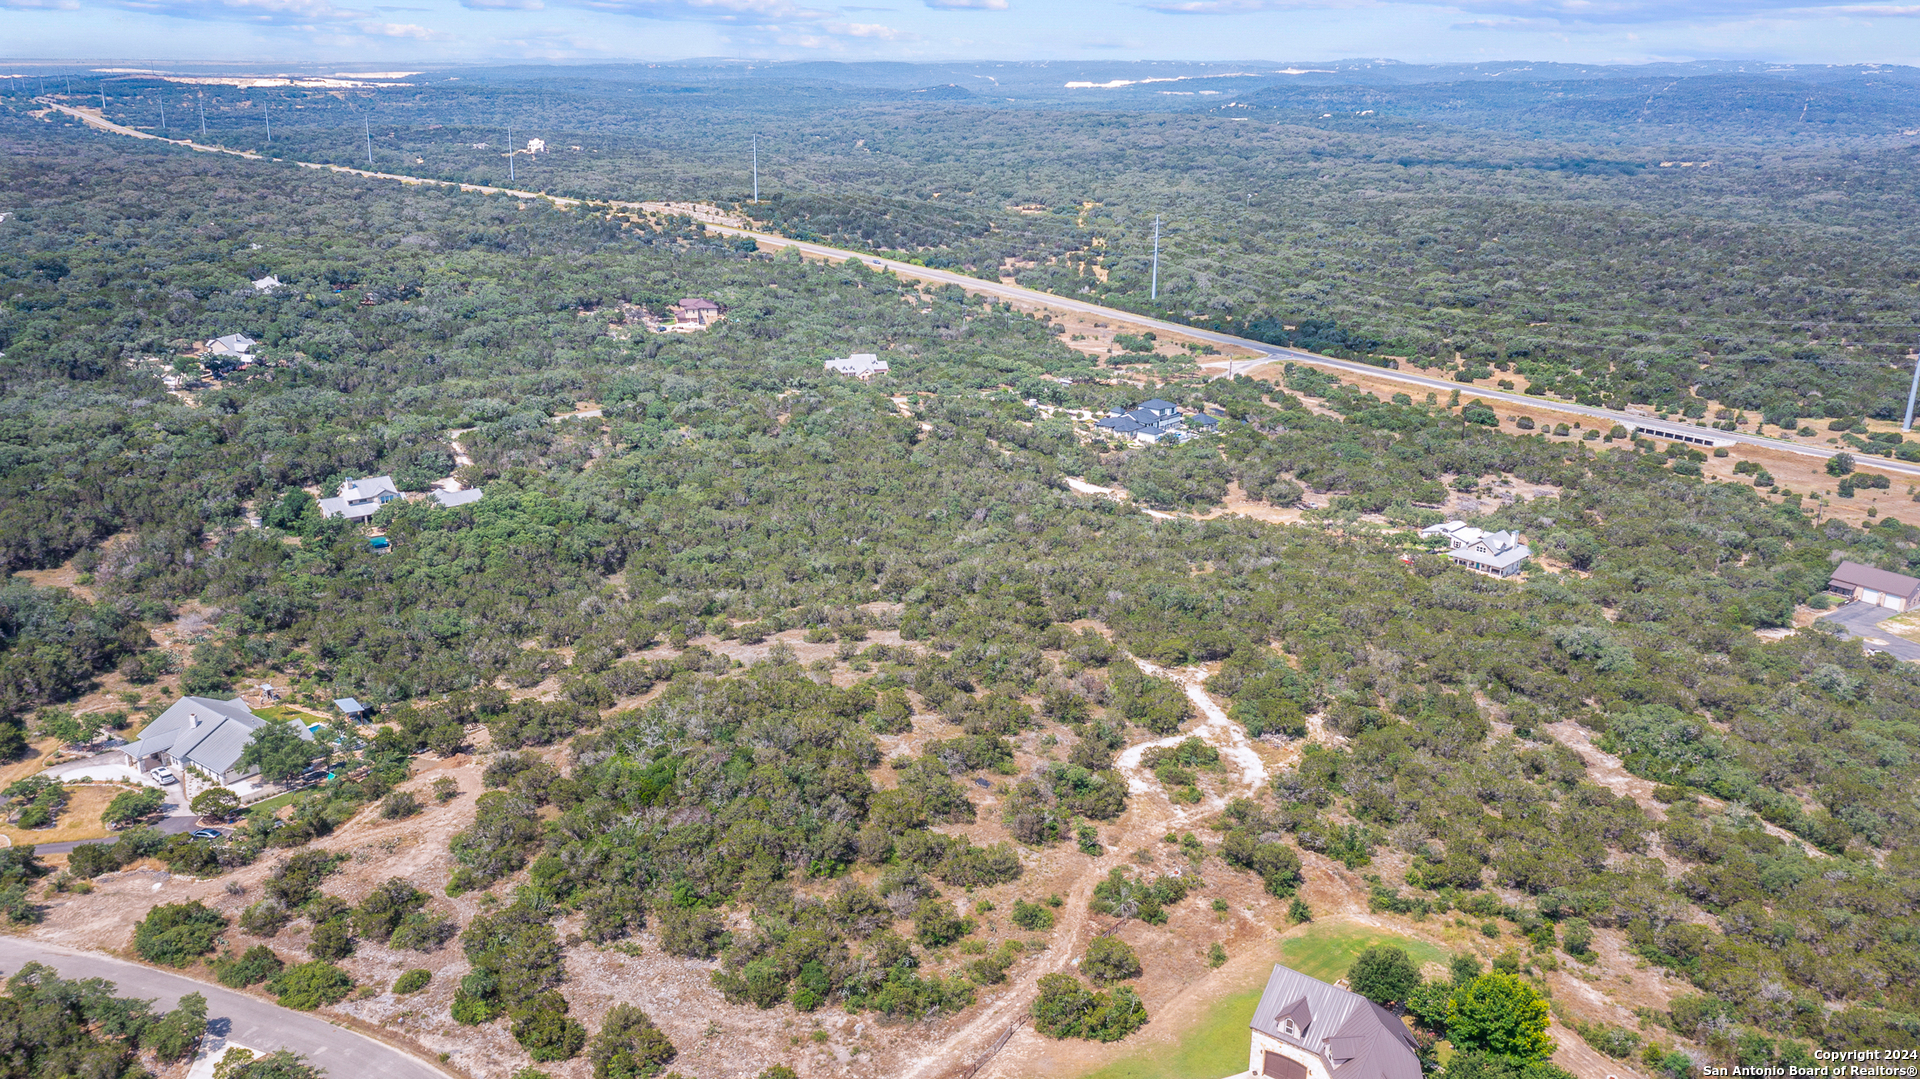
(1085, 922), (1448, 1079)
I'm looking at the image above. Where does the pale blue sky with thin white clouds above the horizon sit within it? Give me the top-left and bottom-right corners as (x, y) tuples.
(11, 0), (1920, 67)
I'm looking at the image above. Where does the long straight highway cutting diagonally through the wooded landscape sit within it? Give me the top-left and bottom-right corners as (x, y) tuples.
(40, 98), (1920, 480)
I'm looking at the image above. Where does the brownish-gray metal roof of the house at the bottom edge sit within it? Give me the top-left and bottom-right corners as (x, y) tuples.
(1250, 964), (1421, 1079)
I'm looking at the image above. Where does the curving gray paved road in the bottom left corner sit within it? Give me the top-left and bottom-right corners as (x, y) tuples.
(0, 937), (449, 1079)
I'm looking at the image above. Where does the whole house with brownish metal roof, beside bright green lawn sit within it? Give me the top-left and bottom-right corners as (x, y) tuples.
(1236, 966), (1421, 1079)
